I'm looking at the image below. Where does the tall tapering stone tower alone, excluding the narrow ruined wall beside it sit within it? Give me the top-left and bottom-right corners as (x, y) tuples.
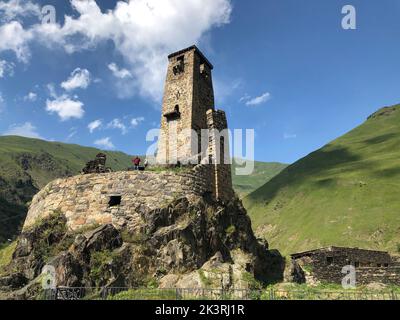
(157, 46), (214, 165)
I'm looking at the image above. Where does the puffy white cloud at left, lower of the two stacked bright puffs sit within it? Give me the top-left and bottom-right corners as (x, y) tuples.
(46, 95), (85, 121)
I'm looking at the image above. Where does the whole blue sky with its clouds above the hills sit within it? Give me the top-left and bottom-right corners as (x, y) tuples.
(0, 0), (400, 163)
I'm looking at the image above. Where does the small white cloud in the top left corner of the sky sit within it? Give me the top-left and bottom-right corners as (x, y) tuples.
(0, 0), (41, 21)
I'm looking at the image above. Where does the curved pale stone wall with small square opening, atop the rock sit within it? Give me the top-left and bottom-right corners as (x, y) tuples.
(24, 166), (216, 234)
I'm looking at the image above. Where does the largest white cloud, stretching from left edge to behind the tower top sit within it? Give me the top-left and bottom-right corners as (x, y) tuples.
(0, 0), (232, 101)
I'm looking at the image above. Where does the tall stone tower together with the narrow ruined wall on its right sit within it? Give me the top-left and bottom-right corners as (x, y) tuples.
(157, 46), (234, 200)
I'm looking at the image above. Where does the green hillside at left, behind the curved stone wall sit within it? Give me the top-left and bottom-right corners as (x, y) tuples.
(0, 136), (131, 243)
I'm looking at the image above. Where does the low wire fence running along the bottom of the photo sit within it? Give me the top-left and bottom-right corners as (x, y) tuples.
(44, 287), (400, 301)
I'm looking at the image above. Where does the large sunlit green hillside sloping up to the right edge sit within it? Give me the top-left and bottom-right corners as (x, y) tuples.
(245, 105), (400, 254)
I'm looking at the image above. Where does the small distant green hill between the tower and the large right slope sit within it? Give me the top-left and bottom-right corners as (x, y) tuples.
(232, 161), (287, 197)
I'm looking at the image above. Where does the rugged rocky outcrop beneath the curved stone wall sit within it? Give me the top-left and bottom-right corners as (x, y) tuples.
(0, 197), (283, 298)
